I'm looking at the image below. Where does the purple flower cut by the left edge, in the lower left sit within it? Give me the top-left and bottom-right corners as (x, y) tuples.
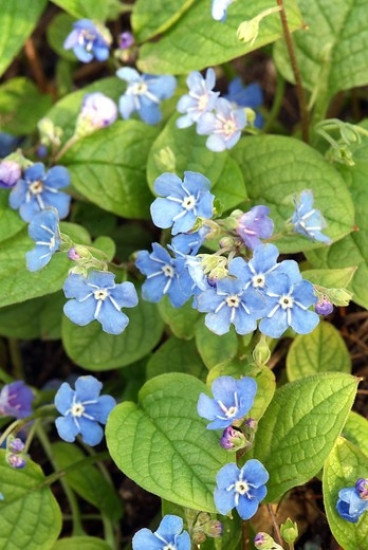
(0, 380), (34, 418)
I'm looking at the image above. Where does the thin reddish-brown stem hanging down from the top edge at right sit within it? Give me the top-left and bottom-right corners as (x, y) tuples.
(276, 0), (309, 143)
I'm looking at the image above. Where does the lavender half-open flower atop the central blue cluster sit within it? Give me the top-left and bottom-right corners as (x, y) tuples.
(236, 205), (274, 250)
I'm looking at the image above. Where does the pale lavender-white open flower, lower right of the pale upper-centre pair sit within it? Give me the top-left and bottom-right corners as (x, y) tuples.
(197, 97), (247, 153)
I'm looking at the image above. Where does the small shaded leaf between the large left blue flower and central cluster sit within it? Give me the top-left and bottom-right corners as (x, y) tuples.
(157, 296), (201, 340)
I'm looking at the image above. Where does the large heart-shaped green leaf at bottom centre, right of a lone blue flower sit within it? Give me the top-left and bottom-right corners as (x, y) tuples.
(106, 373), (229, 512)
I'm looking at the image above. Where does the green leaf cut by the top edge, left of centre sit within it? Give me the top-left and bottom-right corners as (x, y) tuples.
(131, 0), (194, 42)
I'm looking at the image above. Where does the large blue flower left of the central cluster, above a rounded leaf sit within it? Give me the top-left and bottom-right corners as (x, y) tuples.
(63, 271), (138, 334)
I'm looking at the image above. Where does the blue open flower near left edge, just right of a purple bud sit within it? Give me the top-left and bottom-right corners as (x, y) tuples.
(9, 162), (71, 222)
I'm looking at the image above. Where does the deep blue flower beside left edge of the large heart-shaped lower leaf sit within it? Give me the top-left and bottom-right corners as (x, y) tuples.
(55, 375), (116, 445)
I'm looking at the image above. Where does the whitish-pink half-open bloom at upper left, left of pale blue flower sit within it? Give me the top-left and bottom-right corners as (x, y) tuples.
(76, 92), (118, 135)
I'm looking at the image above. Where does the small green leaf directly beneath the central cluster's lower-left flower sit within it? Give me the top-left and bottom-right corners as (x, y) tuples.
(195, 323), (238, 369)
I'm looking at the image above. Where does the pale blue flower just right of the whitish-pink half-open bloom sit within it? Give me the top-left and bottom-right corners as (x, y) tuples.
(116, 67), (176, 124)
